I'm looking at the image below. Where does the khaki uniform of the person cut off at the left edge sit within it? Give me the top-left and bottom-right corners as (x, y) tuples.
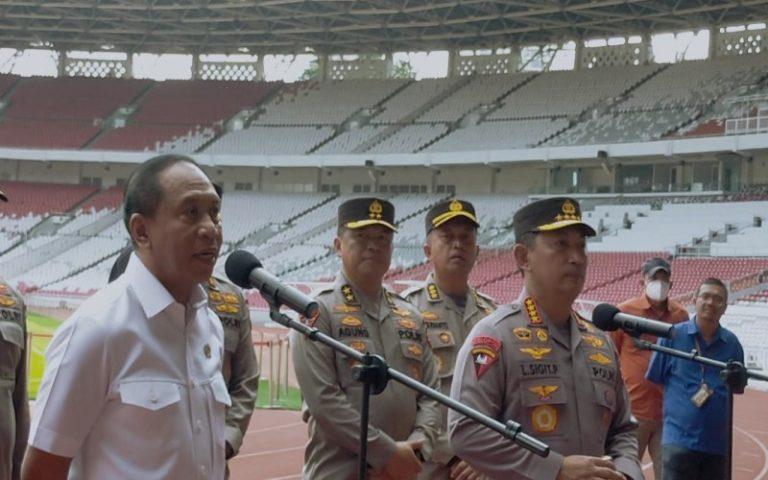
(0, 281), (29, 480)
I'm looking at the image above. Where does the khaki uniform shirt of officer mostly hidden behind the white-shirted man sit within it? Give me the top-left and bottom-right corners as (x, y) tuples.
(205, 277), (259, 455)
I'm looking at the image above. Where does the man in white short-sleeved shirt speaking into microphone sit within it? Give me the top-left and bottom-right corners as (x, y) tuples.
(23, 155), (230, 480)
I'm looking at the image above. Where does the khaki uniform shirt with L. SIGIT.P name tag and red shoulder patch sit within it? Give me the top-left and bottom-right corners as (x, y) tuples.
(448, 299), (643, 480)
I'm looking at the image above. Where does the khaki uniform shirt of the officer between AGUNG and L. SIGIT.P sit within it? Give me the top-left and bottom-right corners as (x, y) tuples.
(402, 273), (496, 470)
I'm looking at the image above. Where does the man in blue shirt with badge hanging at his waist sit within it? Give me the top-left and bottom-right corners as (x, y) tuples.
(646, 278), (744, 480)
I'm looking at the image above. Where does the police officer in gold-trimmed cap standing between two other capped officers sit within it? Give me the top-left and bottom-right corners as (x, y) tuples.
(403, 199), (496, 480)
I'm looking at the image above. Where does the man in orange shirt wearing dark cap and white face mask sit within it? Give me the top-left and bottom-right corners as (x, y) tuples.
(611, 258), (688, 480)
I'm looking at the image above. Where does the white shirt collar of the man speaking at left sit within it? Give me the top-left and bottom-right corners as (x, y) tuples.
(123, 253), (208, 318)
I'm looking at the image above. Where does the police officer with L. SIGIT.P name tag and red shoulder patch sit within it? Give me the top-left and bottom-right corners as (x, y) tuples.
(448, 198), (643, 480)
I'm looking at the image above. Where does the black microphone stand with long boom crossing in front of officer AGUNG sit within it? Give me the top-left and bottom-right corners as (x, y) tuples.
(262, 300), (549, 480)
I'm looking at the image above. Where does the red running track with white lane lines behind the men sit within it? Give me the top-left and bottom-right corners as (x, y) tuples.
(229, 390), (768, 480)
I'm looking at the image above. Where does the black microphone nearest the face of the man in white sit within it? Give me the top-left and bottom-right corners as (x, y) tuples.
(224, 250), (319, 318)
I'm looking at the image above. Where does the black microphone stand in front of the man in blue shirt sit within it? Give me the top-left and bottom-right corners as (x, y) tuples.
(633, 337), (768, 480)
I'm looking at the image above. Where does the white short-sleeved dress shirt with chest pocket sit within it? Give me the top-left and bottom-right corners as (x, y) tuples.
(29, 255), (230, 480)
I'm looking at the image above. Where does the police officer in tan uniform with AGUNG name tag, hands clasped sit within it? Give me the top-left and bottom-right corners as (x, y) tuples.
(292, 198), (439, 480)
